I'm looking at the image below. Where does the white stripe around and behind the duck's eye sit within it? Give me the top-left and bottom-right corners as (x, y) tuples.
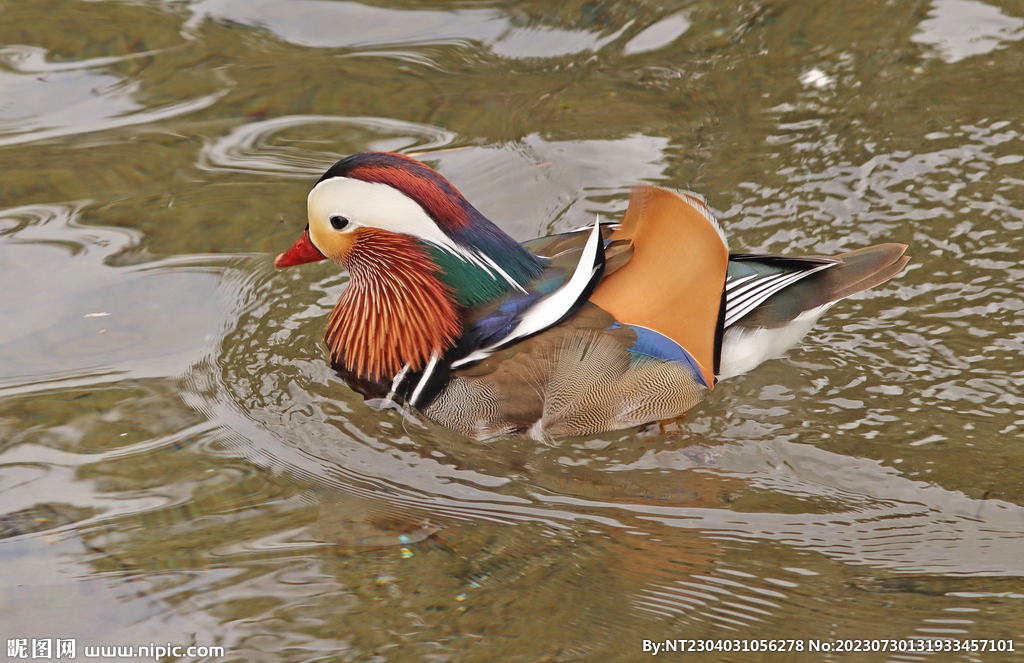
(306, 177), (525, 292)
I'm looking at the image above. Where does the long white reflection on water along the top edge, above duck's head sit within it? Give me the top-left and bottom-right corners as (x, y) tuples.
(186, 0), (630, 57)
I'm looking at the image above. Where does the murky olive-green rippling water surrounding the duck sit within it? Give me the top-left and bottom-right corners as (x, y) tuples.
(0, 0), (1024, 662)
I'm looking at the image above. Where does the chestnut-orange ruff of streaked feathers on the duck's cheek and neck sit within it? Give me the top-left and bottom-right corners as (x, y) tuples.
(324, 227), (462, 382)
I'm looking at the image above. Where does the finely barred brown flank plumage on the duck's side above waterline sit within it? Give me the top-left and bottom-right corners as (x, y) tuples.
(425, 304), (707, 440)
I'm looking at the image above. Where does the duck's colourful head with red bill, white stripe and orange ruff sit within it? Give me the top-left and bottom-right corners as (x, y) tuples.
(274, 153), (544, 382)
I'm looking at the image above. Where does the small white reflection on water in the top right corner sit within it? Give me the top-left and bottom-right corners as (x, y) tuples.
(910, 0), (1024, 64)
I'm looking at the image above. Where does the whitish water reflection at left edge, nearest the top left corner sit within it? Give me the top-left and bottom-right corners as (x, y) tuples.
(0, 46), (230, 147)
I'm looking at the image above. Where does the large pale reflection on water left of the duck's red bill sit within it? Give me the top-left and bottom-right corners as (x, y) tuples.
(0, 204), (250, 396)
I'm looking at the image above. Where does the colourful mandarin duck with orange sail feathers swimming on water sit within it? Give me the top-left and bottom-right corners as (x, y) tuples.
(274, 153), (909, 440)
